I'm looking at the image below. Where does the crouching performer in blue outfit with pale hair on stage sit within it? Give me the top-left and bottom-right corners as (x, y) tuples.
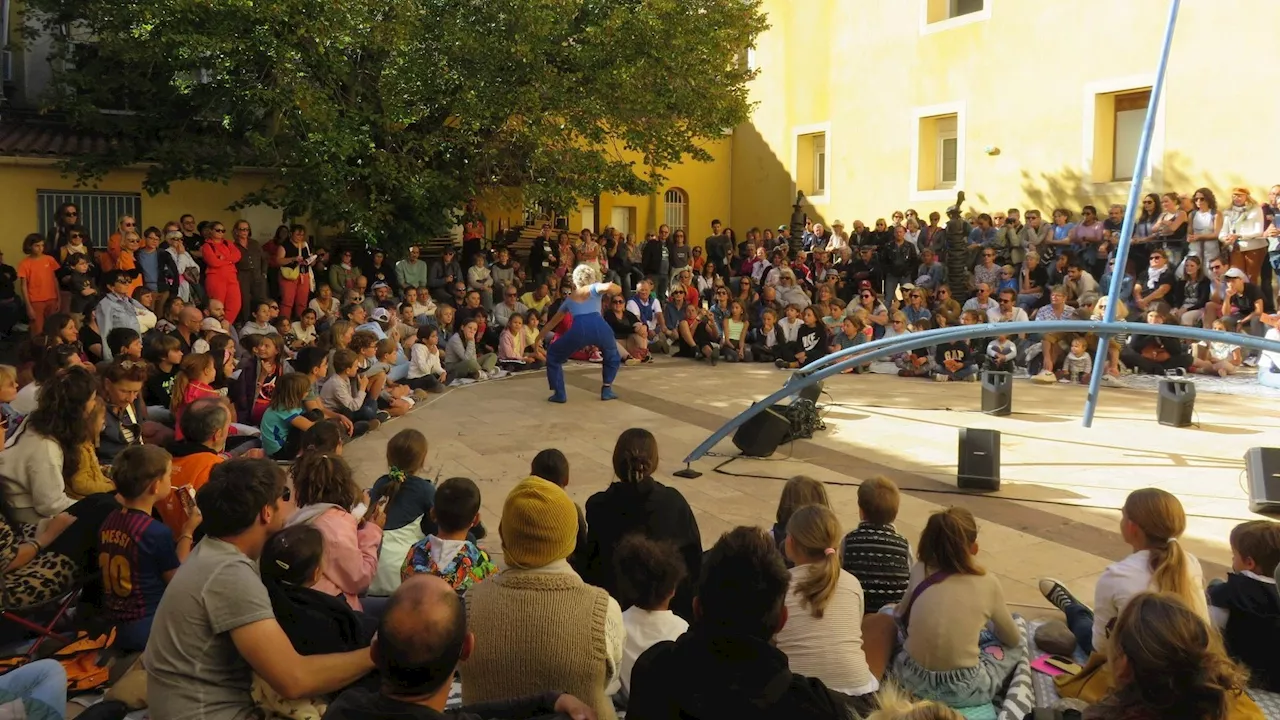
(543, 265), (622, 402)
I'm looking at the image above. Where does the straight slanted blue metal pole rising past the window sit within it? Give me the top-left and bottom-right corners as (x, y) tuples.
(1083, 0), (1181, 428)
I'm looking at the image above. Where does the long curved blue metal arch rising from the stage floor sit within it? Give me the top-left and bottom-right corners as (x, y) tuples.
(685, 320), (1280, 464)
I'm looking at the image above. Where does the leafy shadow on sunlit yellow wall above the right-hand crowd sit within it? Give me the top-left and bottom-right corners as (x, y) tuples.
(1008, 147), (1244, 210)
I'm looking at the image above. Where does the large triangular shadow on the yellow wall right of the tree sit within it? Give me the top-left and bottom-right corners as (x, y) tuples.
(730, 123), (827, 234)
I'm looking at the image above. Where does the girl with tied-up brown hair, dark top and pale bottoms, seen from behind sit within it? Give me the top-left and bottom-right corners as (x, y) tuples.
(369, 428), (436, 596)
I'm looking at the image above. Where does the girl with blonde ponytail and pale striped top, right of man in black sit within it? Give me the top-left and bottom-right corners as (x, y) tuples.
(776, 505), (895, 702)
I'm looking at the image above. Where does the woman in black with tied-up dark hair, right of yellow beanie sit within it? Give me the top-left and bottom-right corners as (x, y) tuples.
(582, 428), (703, 620)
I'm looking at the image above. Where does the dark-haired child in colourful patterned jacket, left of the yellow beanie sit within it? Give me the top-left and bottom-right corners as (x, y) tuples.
(401, 478), (498, 593)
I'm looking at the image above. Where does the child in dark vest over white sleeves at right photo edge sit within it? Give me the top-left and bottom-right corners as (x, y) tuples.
(1208, 520), (1280, 692)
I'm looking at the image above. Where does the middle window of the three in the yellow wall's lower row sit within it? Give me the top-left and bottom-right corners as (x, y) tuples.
(910, 102), (965, 200)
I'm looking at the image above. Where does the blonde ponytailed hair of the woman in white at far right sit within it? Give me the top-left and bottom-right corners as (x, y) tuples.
(1124, 488), (1204, 607)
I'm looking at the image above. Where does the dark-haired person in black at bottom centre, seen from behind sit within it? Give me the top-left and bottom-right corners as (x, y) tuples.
(627, 520), (851, 720)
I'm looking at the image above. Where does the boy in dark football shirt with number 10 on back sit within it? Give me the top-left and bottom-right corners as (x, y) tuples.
(97, 445), (201, 652)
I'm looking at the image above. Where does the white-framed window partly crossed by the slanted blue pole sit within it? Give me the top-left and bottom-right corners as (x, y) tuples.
(1080, 76), (1165, 186)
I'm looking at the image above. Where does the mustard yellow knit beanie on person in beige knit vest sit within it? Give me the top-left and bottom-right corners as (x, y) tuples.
(498, 477), (577, 569)
